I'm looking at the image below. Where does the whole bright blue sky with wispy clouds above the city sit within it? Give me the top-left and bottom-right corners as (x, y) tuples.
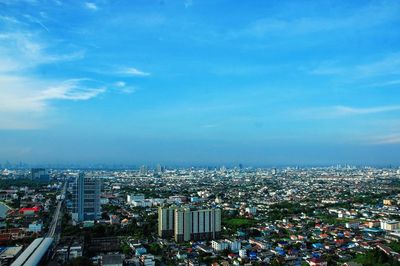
(0, 0), (400, 165)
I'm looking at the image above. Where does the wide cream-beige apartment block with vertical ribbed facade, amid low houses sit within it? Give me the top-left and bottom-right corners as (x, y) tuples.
(158, 207), (221, 242)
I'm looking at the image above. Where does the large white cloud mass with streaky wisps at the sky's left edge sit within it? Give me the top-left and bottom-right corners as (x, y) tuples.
(0, 19), (106, 129)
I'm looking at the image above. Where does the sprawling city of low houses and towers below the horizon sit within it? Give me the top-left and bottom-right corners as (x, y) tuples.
(0, 165), (400, 265)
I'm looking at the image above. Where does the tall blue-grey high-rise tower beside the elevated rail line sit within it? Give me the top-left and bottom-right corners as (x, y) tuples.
(72, 173), (101, 222)
